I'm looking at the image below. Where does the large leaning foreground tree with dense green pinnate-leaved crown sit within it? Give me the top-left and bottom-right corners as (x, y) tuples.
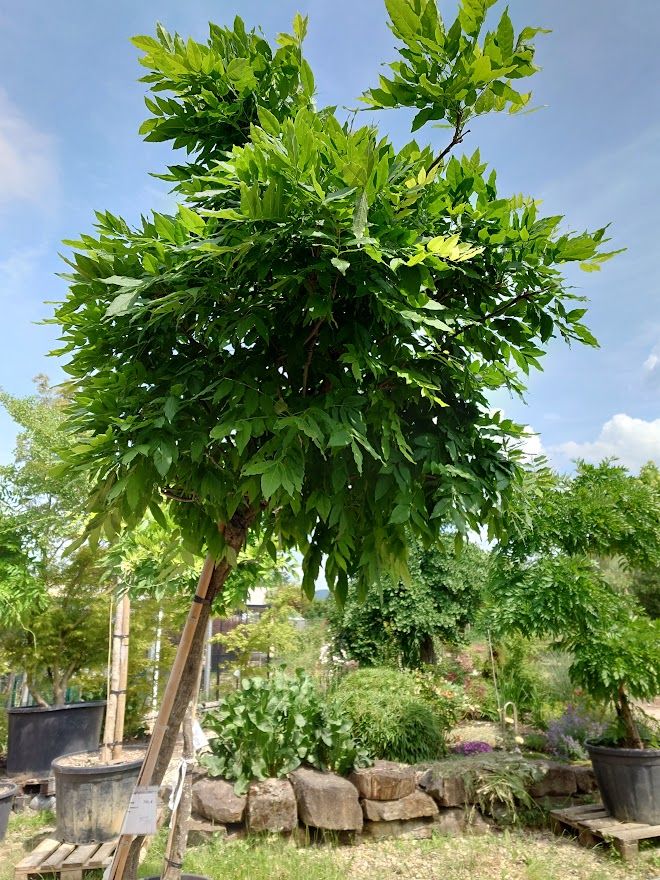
(50, 0), (608, 872)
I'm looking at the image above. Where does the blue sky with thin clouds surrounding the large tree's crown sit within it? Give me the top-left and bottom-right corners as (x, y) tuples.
(0, 0), (660, 468)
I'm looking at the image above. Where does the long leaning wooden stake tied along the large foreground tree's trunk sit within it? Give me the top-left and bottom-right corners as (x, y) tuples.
(105, 556), (215, 880)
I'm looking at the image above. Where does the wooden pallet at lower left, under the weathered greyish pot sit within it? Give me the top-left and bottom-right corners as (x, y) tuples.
(14, 837), (117, 880)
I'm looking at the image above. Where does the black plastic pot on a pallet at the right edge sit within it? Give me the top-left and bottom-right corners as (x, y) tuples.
(587, 743), (660, 825)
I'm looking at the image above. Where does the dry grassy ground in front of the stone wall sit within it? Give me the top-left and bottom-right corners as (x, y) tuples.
(0, 812), (660, 880)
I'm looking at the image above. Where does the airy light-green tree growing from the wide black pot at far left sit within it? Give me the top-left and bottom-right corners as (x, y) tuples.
(0, 377), (110, 705)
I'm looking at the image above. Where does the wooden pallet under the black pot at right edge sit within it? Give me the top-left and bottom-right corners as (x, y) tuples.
(550, 804), (660, 862)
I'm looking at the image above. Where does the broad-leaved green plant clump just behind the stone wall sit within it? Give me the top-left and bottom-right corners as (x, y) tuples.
(201, 670), (368, 793)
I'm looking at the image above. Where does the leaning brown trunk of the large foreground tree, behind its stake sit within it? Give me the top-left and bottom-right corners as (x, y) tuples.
(114, 511), (255, 880)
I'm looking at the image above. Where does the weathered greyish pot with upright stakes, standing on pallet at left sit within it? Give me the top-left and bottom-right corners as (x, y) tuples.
(53, 746), (144, 843)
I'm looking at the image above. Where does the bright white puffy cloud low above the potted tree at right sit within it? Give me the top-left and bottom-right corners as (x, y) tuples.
(552, 413), (660, 471)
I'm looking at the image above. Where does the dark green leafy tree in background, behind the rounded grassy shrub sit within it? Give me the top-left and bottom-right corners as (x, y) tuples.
(331, 538), (488, 669)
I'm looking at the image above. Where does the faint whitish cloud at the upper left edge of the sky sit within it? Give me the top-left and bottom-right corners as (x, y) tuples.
(0, 89), (57, 207)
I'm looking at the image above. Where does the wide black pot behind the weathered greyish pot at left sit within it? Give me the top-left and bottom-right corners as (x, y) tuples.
(7, 700), (105, 777)
